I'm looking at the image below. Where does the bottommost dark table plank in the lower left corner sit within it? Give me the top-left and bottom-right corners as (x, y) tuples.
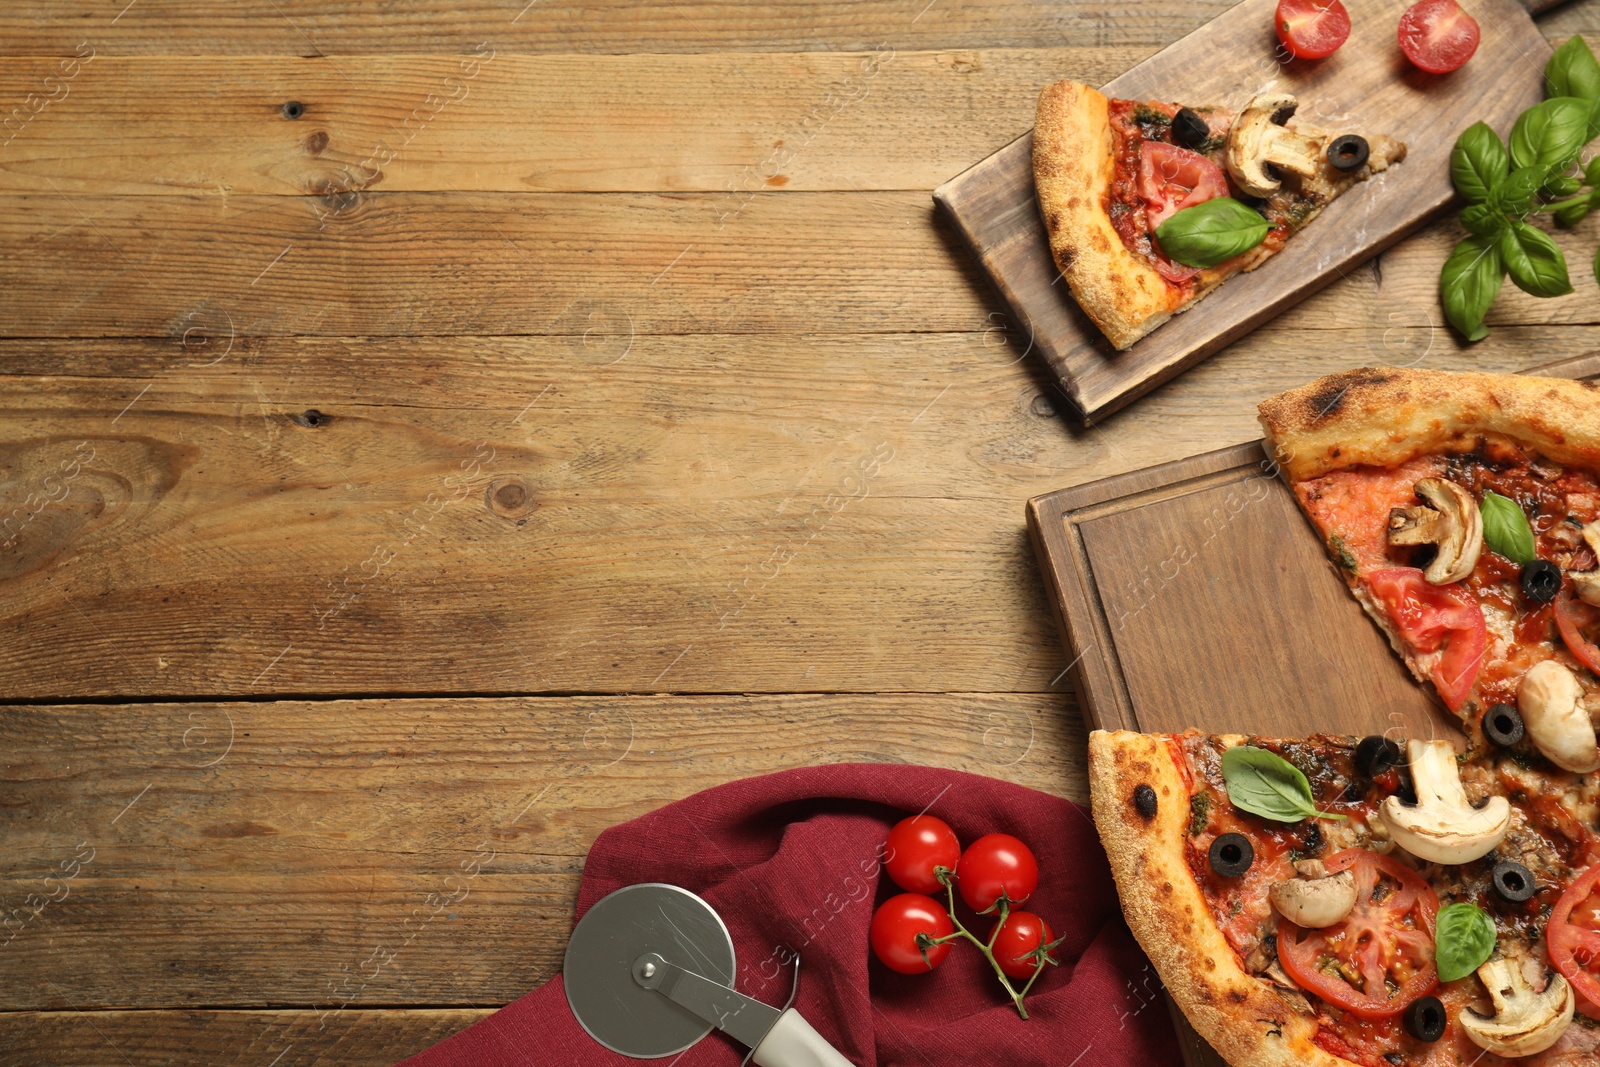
(0, 1008), (493, 1067)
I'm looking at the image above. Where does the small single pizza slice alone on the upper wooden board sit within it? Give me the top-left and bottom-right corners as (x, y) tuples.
(1034, 80), (1405, 349)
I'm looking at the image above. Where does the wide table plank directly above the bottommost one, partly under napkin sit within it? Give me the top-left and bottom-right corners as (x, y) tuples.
(0, 693), (1086, 1025)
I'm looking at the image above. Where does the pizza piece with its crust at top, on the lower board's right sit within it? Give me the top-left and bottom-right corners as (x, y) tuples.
(1261, 368), (1600, 758)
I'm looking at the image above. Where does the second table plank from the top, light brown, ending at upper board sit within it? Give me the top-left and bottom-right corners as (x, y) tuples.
(0, 48), (1144, 194)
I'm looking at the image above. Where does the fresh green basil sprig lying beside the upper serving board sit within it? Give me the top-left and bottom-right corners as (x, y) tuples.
(1438, 37), (1600, 341)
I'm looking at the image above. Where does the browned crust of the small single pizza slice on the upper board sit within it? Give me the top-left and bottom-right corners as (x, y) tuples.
(1034, 80), (1182, 349)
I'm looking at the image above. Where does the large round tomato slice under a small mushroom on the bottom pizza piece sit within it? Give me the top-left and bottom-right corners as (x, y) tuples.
(1278, 848), (1438, 1019)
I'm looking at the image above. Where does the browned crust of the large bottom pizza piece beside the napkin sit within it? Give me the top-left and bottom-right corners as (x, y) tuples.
(1090, 729), (1350, 1067)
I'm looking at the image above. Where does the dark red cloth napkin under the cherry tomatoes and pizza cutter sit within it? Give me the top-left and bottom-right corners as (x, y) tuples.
(395, 763), (1179, 1067)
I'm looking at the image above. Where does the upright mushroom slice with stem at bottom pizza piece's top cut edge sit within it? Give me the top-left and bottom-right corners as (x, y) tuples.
(1378, 741), (1510, 864)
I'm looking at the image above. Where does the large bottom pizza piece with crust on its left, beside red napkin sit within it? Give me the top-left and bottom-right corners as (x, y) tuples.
(1090, 731), (1600, 1067)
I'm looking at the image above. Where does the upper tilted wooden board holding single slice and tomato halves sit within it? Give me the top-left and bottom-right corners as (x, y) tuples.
(933, 0), (1560, 424)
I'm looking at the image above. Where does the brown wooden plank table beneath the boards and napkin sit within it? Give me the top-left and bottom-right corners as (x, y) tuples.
(0, 0), (1600, 1067)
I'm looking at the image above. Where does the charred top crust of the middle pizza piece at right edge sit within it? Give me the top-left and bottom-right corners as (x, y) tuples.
(1261, 366), (1600, 482)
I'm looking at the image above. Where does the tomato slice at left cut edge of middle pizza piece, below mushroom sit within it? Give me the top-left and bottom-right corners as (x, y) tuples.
(1366, 566), (1488, 712)
